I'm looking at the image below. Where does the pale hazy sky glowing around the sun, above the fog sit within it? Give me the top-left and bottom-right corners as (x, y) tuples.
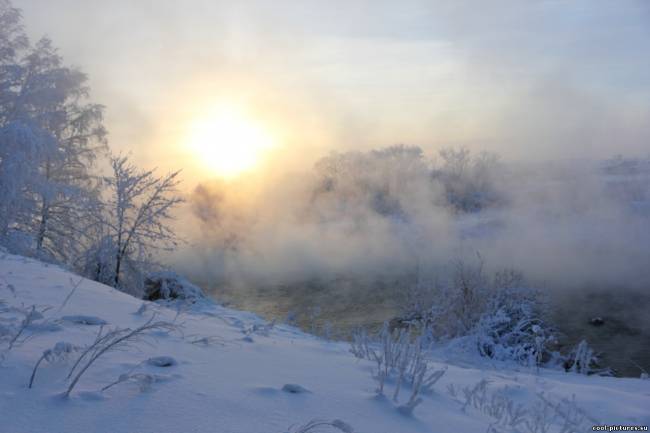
(15, 0), (650, 182)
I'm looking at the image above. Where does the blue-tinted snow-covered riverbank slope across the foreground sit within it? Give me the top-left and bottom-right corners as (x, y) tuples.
(0, 255), (650, 433)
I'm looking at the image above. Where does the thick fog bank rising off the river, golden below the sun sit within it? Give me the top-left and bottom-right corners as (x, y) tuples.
(175, 146), (650, 296)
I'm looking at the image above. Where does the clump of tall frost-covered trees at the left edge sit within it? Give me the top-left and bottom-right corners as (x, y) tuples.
(0, 0), (106, 263)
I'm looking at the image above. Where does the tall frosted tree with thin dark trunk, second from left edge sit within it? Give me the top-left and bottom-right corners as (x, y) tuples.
(15, 39), (106, 261)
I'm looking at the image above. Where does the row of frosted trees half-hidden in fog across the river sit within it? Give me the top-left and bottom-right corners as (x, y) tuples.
(305, 145), (504, 223)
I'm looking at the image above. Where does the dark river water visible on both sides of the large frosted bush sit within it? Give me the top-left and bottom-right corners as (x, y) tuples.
(204, 278), (650, 377)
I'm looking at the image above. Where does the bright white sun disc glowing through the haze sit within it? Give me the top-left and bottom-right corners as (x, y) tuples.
(187, 108), (274, 178)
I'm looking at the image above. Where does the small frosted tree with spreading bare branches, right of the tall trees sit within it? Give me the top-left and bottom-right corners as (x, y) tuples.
(87, 156), (183, 290)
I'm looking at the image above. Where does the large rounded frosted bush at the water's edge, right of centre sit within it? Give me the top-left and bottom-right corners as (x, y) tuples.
(401, 256), (559, 366)
